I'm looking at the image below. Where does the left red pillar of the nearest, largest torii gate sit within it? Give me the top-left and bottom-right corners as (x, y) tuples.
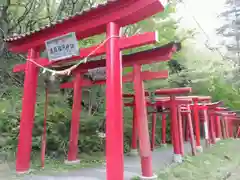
(16, 49), (39, 173)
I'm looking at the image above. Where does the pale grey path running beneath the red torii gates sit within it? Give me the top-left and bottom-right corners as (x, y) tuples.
(24, 144), (200, 180)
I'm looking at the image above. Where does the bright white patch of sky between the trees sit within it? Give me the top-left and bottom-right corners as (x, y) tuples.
(177, 0), (225, 44)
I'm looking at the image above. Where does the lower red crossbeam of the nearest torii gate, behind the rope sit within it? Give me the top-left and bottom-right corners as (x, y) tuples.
(13, 32), (156, 72)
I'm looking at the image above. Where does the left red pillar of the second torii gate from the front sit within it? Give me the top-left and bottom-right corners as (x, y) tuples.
(68, 74), (82, 161)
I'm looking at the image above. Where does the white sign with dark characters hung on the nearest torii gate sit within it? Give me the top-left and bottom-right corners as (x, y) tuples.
(45, 32), (79, 61)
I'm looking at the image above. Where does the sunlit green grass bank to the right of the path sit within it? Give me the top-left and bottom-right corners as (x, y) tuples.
(158, 140), (240, 180)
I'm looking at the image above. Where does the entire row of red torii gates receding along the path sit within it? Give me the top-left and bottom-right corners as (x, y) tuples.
(5, 0), (238, 180)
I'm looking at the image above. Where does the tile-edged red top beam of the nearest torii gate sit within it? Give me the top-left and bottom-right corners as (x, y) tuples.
(5, 0), (167, 53)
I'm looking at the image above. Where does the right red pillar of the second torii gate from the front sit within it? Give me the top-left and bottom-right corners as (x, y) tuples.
(133, 65), (153, 177)
